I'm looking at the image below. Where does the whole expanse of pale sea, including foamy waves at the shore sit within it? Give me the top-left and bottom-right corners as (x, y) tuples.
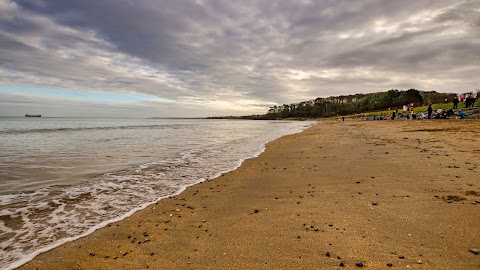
(0, 118), (313, 269)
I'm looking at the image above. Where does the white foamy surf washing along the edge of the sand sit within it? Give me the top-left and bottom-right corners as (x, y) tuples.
(0, 122), (313, 269)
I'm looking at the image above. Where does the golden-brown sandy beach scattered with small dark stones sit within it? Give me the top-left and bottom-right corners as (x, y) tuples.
(17, 120), (480, 269)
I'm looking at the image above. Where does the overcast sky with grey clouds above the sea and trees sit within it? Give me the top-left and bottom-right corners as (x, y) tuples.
(0, 0), (480, 117)
